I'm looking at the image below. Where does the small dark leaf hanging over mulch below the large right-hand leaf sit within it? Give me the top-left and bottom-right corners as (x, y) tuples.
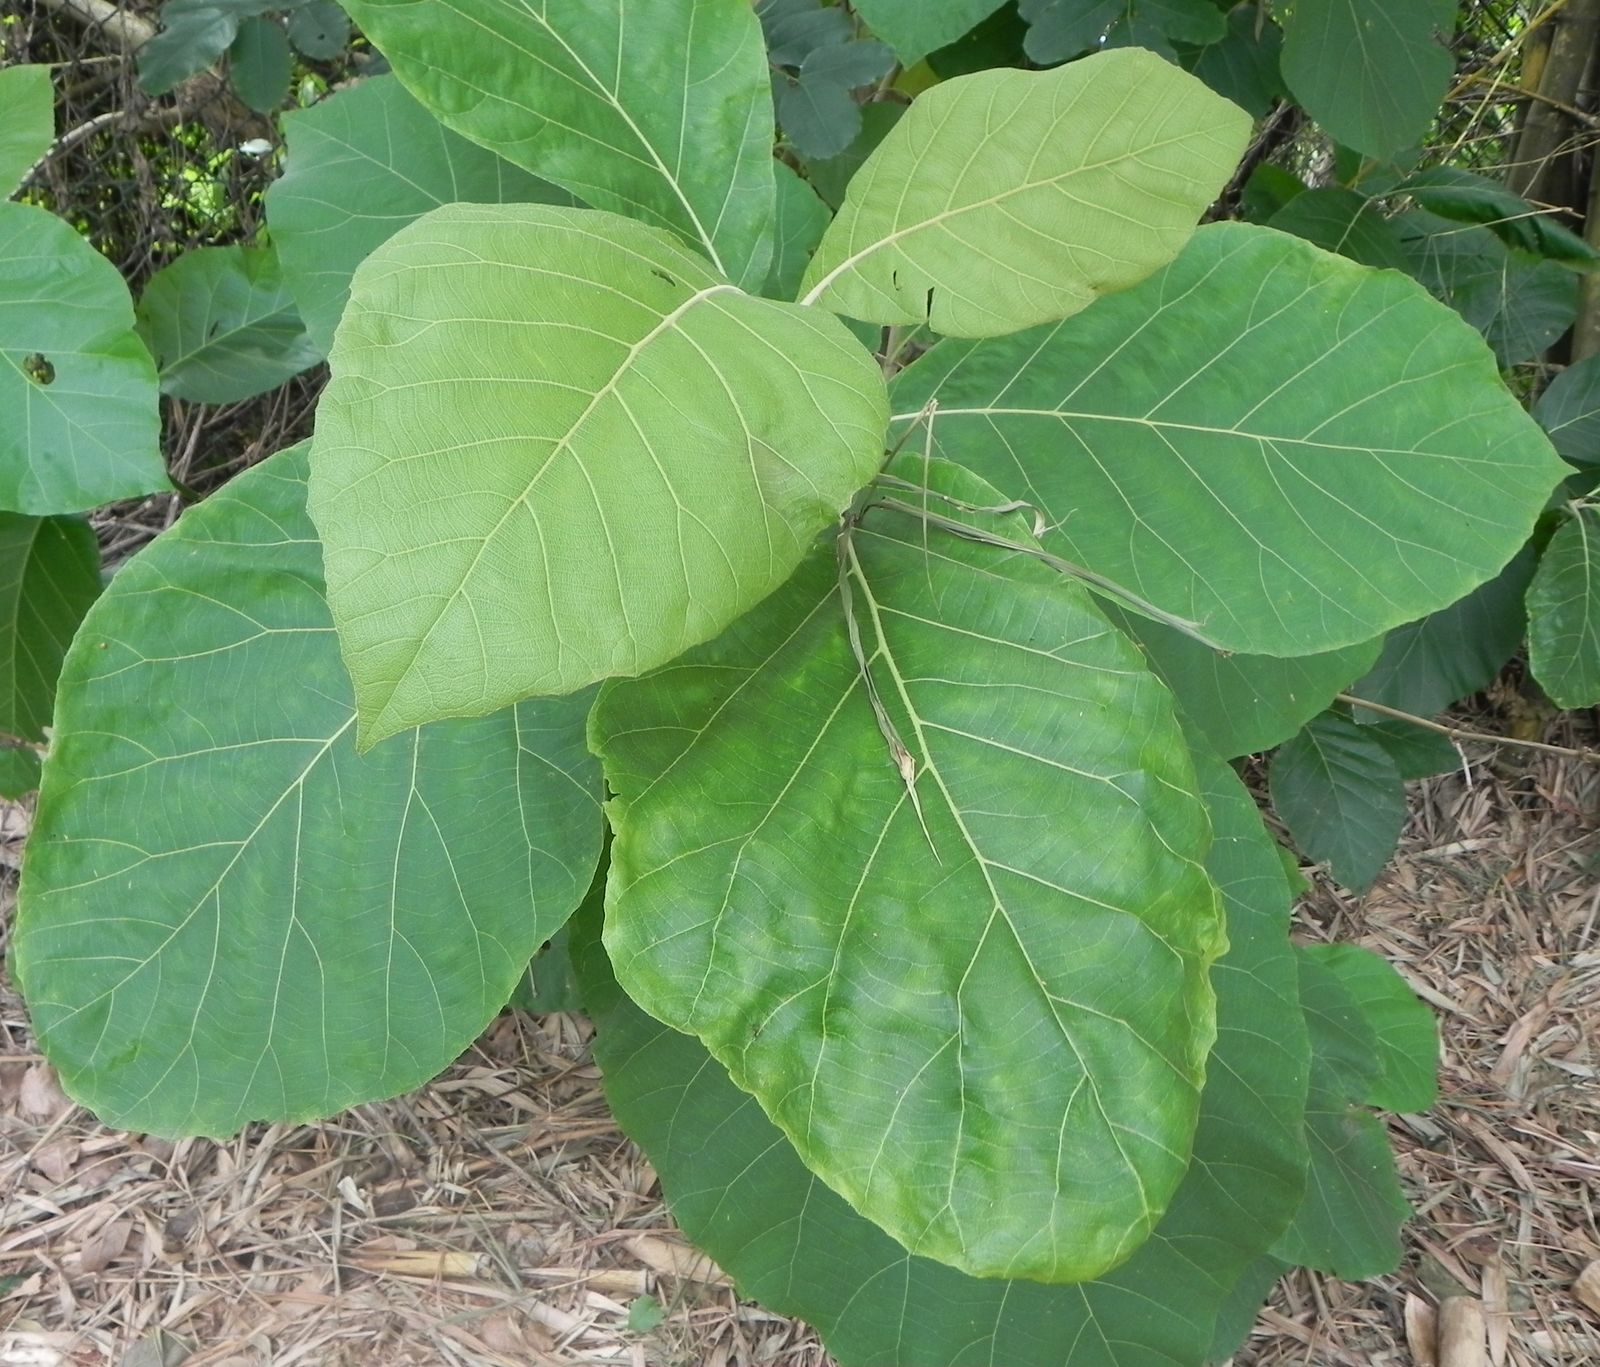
(1272, 712), (1405, 892)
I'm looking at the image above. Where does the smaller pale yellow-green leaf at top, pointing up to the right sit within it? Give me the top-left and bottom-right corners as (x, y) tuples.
(803, 51), (1250, 336)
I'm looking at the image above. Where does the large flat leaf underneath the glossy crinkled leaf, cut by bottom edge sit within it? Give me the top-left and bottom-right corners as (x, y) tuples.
(574, 760), (1307, 1367)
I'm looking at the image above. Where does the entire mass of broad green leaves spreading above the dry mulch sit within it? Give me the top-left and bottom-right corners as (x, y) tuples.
(0, 13), (1574, 1367)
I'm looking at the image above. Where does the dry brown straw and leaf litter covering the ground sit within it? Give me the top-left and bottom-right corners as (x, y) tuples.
(0, 739), (1600, 1367)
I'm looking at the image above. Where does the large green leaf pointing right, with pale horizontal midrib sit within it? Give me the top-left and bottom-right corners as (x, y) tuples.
(894, 225), (1565, 655)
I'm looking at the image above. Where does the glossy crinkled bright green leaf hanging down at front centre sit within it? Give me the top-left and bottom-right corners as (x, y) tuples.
(592, 471), (1221, 1281)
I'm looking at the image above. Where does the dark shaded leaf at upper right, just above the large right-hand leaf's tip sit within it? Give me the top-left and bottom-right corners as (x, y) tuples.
(1392, 210), (1579, 367)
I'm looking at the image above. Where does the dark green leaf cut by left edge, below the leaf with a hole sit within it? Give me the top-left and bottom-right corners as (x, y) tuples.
(0, 512), (101, 741)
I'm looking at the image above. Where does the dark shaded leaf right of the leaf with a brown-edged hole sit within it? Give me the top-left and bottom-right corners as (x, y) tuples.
(138, 247), (323, 403)
